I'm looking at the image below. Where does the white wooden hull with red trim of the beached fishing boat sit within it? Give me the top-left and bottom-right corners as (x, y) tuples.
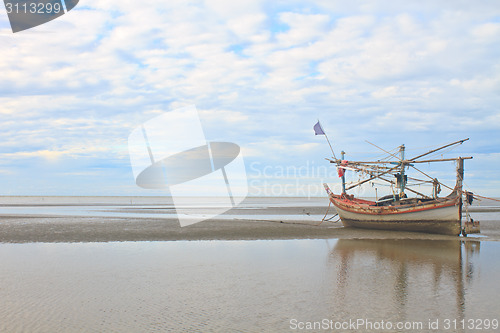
(327, 184), (461, 235)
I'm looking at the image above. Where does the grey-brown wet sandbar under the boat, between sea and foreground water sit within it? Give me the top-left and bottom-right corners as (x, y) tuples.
(0, 210), (500, 243)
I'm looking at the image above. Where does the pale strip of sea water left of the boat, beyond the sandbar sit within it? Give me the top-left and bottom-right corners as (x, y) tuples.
(0, 196), (328, 221)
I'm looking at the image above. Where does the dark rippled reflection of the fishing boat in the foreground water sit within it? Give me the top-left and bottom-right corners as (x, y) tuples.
(328, 239), (480, 329)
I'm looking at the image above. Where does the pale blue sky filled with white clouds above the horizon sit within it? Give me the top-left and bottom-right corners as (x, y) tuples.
(0, 0), (500, 197)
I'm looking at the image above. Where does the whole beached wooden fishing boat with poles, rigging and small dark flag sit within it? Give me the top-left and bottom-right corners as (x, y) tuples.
(315, 128), (479, 236)
